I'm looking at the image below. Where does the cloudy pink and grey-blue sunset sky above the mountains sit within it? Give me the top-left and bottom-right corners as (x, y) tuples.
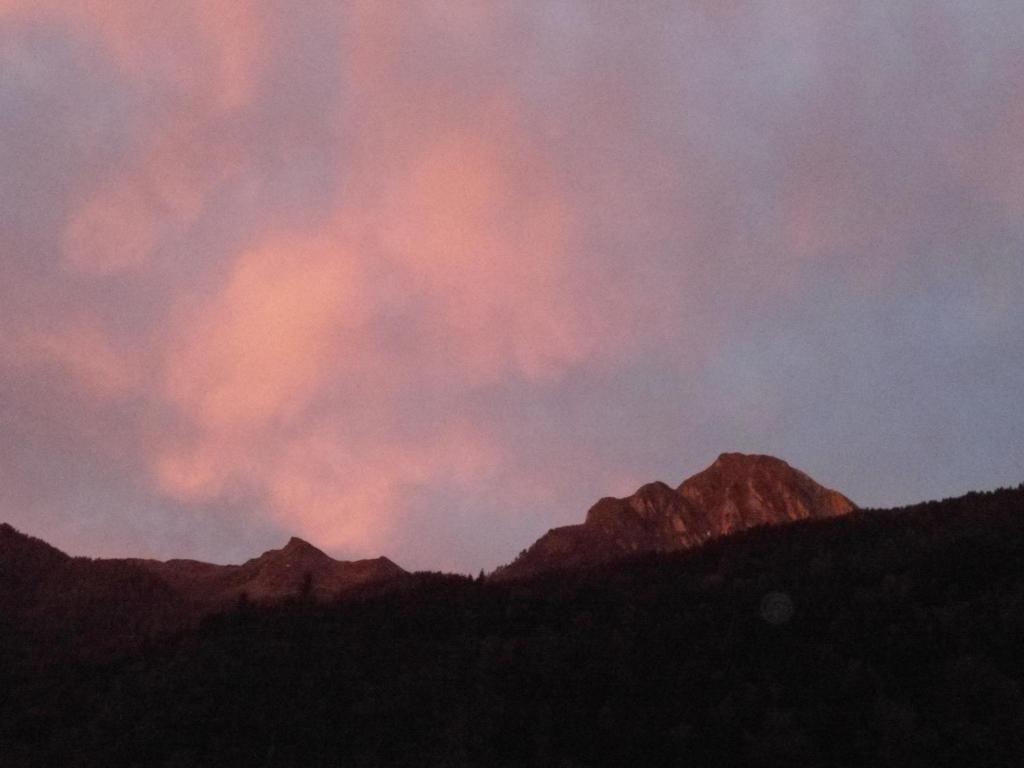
(0, 0), (1024, 572)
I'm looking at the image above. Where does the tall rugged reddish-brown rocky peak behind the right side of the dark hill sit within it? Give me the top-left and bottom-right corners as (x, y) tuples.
(492, 454), (856, 580)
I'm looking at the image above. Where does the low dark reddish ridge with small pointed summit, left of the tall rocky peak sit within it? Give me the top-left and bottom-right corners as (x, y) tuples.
(0, 523), (406, 654)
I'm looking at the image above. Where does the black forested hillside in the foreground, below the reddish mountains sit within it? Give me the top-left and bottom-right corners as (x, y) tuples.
(0, 485), (1024, 768)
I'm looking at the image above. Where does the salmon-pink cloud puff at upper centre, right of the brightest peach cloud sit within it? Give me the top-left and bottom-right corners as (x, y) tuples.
(361, 108), (600, 381)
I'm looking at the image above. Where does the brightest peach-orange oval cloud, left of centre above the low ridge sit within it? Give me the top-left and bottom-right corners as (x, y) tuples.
(161, 228), (368, 430)
